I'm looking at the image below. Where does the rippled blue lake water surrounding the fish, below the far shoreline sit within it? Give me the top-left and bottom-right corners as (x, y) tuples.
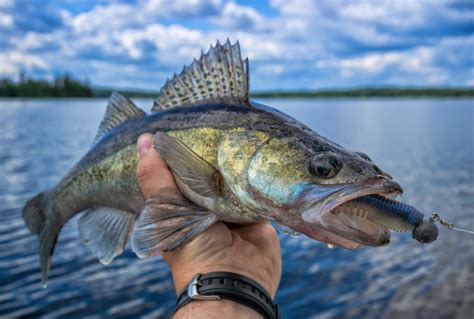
(0, 99), (474, 319)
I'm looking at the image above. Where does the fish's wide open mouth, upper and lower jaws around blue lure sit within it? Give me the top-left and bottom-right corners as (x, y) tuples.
(301, 178), (403, 249)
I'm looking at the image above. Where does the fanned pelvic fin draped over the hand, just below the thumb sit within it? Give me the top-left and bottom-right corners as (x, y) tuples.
(132, 194), (217, 258)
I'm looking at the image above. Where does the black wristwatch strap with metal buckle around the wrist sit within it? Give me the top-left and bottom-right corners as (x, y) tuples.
(175, 272), (280, 319)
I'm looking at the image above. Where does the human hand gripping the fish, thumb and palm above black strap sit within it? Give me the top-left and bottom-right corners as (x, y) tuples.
(137, 134), (281, 297)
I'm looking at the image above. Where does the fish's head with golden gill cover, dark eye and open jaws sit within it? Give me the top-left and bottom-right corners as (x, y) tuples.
(248, 134), (402, 248)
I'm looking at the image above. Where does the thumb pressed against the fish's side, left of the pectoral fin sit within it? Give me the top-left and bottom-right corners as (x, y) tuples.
(136, 133), (181, 199)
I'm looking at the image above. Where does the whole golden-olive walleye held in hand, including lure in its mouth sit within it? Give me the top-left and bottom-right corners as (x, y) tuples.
(23, 40), (435, 280)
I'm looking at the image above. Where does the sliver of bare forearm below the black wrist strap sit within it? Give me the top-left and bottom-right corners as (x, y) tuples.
(173, 299), (262, 319)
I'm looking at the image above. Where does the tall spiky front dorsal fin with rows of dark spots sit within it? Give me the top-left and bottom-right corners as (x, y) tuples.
(152, 39), (249, 112)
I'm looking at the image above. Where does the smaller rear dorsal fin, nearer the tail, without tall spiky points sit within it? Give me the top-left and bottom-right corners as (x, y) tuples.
(94, 92), (145, 142)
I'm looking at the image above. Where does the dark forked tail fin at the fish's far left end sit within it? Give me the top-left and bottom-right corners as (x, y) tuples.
(22, 192), (59, 285)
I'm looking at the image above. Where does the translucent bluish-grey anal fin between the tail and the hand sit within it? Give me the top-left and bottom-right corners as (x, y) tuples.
(79, 207), (135, 265)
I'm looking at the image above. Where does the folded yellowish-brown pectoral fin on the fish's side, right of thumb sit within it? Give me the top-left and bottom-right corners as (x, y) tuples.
(154, 132), (221, 199)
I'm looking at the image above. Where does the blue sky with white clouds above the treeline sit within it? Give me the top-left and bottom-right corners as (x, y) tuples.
(0, 0), (474, 92)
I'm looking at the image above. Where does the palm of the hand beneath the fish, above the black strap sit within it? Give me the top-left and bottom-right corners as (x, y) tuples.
(163, 222), (281, 296)
